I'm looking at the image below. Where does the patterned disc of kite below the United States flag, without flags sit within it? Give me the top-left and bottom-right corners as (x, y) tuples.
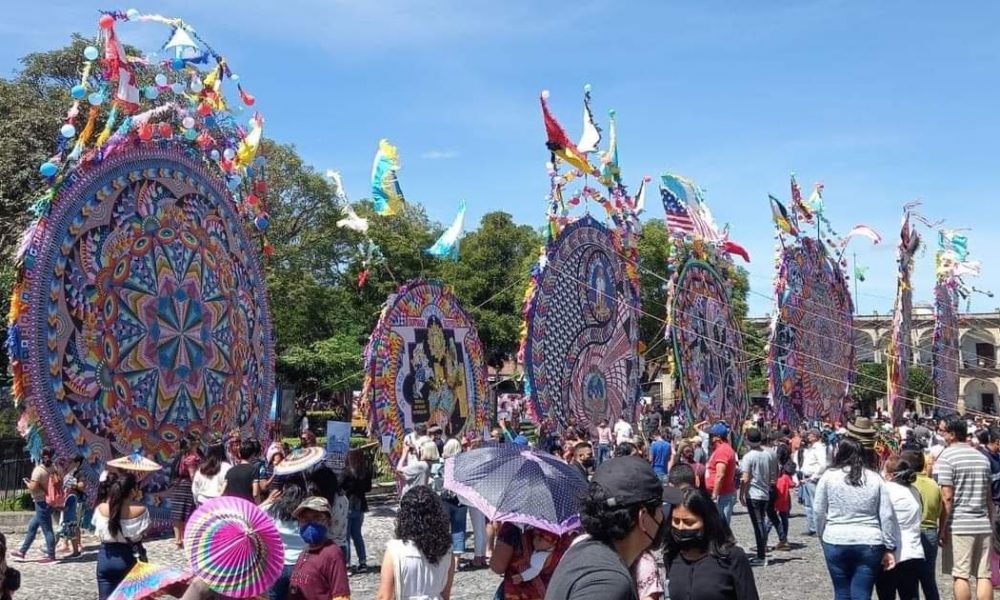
(668, 256), (749, 444)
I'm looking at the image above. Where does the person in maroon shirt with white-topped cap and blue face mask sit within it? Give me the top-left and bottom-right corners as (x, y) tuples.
(288, 496), (351, 600)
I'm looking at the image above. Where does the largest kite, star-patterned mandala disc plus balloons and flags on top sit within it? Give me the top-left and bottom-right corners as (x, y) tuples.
(8, 10), (274, 516)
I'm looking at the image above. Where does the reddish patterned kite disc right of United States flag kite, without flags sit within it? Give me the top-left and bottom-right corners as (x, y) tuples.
(768, 238), (854, 425)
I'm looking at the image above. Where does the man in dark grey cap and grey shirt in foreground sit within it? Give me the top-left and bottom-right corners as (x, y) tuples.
(545, 456), (680, 600)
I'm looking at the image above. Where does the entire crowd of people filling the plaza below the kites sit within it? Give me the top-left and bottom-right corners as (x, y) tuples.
(0, 408), (1000, 600)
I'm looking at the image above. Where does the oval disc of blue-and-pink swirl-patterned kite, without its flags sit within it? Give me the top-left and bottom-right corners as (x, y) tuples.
(524, 215), (639, 427)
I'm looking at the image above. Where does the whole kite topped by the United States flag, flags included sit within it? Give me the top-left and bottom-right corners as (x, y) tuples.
(660, 174), (750, 446)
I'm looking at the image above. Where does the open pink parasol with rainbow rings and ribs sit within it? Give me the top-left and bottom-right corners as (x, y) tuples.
(184, 496), (285, 598)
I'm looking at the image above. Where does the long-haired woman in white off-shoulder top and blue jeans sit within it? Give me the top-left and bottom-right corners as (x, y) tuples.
(94, 473), (149, 600)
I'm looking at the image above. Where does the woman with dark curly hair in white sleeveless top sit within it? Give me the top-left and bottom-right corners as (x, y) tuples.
(378, 485), (455, 600)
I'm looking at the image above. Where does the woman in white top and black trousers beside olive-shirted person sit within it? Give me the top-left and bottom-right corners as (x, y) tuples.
(875, 455), (924, 600)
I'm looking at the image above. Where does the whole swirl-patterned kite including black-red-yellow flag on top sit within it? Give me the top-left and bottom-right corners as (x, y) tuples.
(519, 90), (641, 427)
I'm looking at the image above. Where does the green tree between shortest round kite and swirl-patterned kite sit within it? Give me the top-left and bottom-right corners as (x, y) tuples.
(441, 212), (543, 366)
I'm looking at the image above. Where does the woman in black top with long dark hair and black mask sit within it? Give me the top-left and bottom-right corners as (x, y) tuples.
(663, 488), (759, 600)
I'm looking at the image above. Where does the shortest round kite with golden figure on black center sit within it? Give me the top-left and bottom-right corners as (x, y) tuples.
(363, 279), (489, 456)
